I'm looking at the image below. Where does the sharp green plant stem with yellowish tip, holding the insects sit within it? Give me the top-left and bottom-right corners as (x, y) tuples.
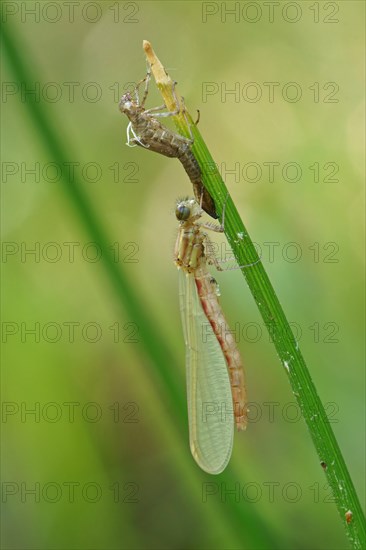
(143, 41), (366, 550)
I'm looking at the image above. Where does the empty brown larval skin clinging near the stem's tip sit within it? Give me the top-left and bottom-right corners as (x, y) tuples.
(119, 72), (217, 218)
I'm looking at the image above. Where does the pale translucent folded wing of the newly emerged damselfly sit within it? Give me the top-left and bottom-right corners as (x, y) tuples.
(179, 269), (234, 474)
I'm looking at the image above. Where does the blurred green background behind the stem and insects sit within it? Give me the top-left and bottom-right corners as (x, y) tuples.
(2, 1), (365, 550)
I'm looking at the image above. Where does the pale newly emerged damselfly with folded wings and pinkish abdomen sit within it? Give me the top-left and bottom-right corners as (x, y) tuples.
(175, 199), (248, 474)
